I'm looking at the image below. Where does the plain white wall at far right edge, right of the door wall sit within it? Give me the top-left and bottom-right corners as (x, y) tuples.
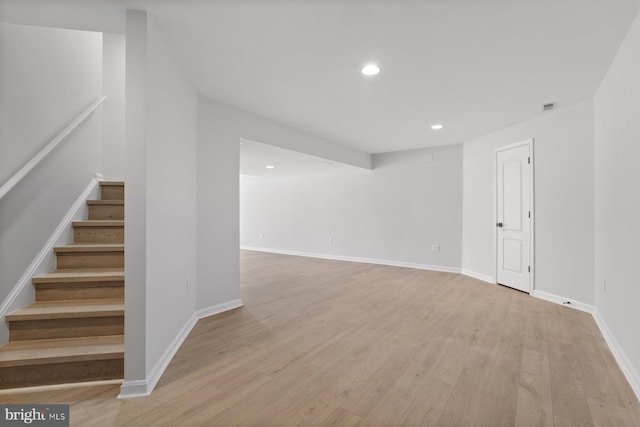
(594, 10), (640, 396)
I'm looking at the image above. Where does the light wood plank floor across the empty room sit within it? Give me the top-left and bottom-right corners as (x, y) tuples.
(0, 252), (640, 427)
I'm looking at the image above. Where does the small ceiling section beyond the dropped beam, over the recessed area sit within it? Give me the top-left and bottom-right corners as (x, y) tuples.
(240, 139), (362, 178)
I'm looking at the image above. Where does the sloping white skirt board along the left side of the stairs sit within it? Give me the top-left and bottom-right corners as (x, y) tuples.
(0, 174), (101, 344)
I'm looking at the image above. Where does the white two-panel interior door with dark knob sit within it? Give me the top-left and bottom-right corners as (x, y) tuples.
(496, 143), (532, 293)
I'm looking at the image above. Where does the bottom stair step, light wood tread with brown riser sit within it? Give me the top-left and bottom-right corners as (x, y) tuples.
(0, 335), (124, 389)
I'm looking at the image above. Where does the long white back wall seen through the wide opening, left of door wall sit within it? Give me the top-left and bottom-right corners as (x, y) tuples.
(240, 145), (462, 270)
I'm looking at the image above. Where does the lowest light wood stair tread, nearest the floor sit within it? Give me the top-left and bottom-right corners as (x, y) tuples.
(0, 335), (124, 367)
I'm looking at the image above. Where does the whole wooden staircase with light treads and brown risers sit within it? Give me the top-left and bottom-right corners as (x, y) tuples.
(0, 182), (124, 389)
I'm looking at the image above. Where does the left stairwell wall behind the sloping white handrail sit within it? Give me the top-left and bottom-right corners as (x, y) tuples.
(0, 23), (102, 338)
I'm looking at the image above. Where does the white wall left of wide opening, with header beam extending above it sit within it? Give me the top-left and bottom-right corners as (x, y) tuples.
(197, 97), (371, 309)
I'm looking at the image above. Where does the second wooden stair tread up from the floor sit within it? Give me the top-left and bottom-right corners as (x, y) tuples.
(6, 299), (124, 321)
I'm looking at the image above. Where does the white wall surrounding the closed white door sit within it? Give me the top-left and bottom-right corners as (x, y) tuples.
(462, 101), (594, 304)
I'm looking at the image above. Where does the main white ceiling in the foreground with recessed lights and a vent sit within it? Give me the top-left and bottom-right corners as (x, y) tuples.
(3, 0), (639, 153)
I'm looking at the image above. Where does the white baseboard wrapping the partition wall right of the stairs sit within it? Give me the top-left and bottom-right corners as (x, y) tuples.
(118, 298), (242, 399)
